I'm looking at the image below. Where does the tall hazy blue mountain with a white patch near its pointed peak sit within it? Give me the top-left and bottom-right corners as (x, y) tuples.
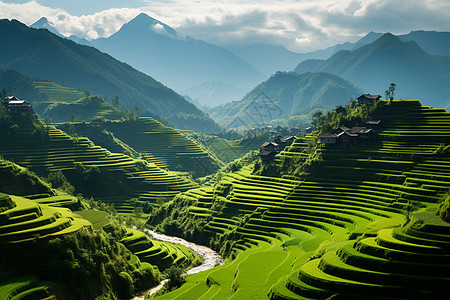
(91, 13), (265, 97)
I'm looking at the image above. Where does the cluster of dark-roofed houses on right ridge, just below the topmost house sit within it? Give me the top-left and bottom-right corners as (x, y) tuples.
(319, 120), (381, 144)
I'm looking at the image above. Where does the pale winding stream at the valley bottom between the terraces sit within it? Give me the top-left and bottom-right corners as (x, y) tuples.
(133, 229), (223, 300)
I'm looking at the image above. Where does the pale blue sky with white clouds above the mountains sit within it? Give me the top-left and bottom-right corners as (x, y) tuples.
(0, 0), (450, 52)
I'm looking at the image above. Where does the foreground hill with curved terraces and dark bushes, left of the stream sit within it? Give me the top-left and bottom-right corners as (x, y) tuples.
(0, 160), (198, 299)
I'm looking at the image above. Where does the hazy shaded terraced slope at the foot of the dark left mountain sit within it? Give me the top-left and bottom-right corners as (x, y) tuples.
(104, 117), (220, 177)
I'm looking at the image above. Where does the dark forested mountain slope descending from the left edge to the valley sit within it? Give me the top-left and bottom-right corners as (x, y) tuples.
(0, 20), (219, 131)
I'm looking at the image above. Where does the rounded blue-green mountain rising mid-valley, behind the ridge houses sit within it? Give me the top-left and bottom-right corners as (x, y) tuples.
(208, 72), (361, 128)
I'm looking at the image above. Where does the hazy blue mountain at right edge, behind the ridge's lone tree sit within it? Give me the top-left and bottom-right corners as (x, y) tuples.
(295, 33), (450, 107)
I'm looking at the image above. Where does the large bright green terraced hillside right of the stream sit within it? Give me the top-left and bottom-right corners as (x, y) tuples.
(151, 101), (450, 299)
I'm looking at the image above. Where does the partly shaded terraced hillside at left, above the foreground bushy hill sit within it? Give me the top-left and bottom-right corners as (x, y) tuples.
(0, 117), (196, 213)
